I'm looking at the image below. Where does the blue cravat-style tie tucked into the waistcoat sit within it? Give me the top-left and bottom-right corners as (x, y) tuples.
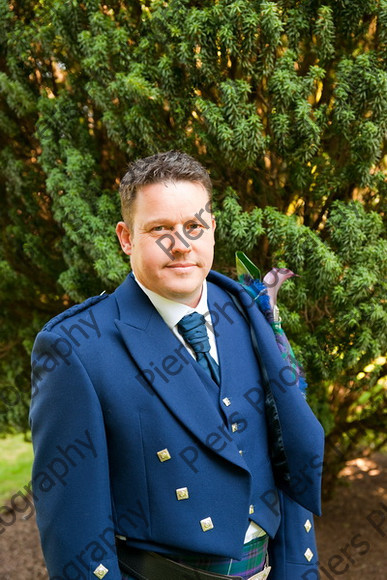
(177, 312), (220, 385)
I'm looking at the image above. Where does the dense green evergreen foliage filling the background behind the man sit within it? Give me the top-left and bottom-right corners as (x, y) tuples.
(0, 0), (387, 492)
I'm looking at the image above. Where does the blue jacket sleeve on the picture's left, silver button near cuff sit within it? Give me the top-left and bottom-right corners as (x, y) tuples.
(30, 330), (121, 580)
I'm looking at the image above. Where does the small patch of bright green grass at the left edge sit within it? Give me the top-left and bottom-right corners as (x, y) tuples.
(0, 433), (32, 502)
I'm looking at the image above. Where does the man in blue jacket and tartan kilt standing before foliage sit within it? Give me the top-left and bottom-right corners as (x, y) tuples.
(31, 151), (323, 580)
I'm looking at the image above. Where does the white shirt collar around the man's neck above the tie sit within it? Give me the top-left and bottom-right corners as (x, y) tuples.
(133, 273), (208, 329)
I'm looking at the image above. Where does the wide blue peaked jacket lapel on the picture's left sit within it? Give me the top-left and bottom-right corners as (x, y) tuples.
(114, 276), (247, 469)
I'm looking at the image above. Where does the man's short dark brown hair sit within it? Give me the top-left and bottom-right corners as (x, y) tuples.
(119, 151), (212, 226)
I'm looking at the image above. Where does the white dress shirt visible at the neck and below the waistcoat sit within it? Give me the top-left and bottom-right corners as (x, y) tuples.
(134, 276), (266, 544)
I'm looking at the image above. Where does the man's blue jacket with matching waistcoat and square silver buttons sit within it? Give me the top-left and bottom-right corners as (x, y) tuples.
(30, 272), (323, 580)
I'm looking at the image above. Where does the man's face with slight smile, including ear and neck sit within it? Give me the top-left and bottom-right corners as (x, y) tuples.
(116, 181), (215, 307)
